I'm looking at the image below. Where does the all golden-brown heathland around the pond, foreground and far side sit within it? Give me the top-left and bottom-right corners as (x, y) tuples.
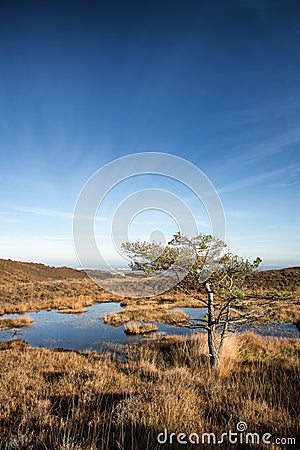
(0, 260), (300, 450)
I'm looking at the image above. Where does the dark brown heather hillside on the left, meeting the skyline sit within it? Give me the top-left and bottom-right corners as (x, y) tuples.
(0, 259), (86, 282)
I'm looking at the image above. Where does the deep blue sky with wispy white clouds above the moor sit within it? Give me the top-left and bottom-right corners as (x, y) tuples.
(0, 0), (300, 267)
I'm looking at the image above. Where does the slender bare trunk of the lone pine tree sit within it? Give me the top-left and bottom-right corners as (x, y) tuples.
(205, 283), (219, 370)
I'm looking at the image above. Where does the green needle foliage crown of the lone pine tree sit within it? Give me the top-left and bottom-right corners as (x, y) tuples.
(122, 232), (261, 298)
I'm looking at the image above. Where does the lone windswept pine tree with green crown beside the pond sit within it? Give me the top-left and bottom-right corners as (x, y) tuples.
(122, 232), (262, 370)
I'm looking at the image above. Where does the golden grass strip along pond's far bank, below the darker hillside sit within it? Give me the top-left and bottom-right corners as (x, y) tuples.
(0, 278), (300, 332)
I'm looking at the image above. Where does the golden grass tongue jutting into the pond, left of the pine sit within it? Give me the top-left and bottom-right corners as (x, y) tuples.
(103, 305), (188, 327)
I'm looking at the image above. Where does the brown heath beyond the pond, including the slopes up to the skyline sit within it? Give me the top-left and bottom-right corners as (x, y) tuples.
(0, 260), (300, 323)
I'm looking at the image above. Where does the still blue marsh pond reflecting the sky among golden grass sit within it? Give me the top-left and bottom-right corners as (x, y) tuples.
(0, 302), (299, 351)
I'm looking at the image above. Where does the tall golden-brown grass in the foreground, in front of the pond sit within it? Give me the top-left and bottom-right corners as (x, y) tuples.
(0, 333), (300, 450)
